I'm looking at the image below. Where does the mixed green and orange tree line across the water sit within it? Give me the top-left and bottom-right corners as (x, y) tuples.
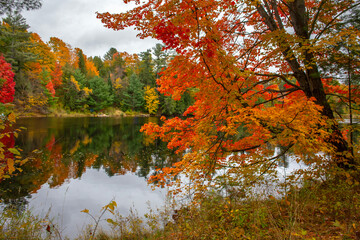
(0, 1), (193, 115)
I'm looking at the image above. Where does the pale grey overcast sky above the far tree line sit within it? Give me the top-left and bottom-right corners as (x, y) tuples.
(22, 0), (157, 57)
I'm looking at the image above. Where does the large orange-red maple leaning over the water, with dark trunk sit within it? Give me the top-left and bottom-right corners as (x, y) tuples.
(98, 0), (359, 195)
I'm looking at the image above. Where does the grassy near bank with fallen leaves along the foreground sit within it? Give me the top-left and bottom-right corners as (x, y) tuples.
(0, 181), (360, 240)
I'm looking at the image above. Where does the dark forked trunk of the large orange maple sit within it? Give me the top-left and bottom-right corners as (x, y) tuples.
(257, 0), (355, 169)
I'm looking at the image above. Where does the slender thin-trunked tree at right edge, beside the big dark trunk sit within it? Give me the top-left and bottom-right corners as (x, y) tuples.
(319, 7), (360, 154)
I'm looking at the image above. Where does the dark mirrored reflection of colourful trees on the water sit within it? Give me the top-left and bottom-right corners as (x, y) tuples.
(0, 117), (179, 210)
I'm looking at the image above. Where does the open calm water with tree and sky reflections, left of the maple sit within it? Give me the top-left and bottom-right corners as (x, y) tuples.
(0, 117), (178, 237)
